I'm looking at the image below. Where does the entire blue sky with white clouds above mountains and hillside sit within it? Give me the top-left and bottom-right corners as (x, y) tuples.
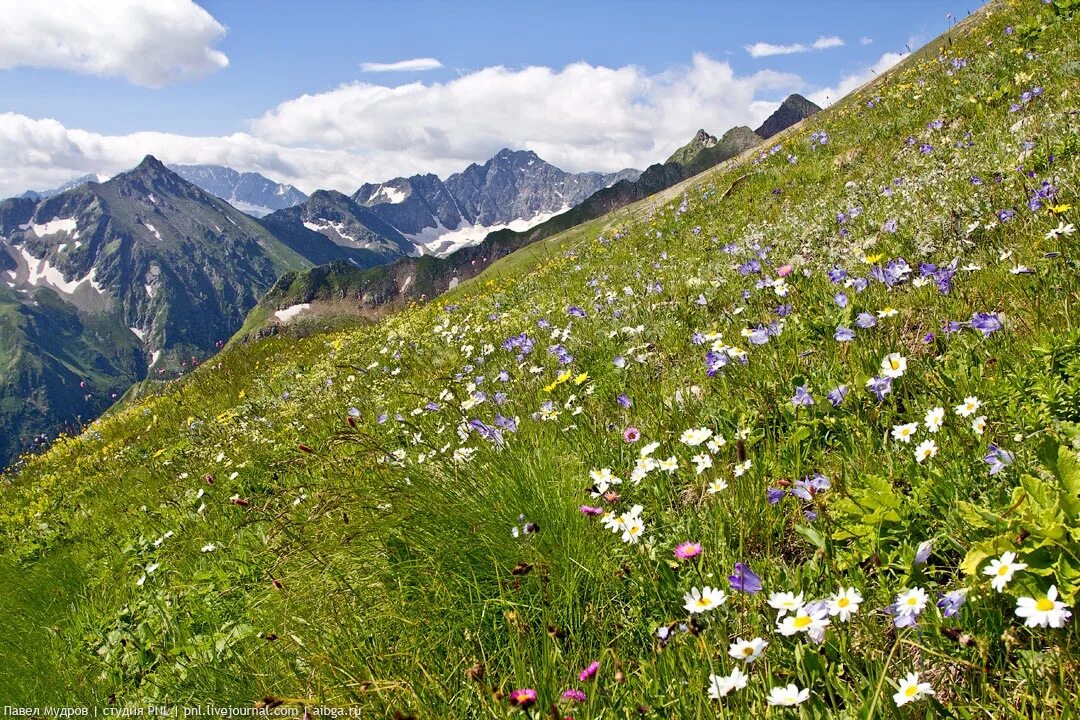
(0, 0), (967, 194)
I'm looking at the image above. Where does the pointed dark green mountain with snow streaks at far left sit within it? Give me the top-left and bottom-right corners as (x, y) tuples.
(0, 158), (347, 465)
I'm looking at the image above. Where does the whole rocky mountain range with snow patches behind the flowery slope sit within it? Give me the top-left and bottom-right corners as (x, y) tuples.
(0, 92), (806, 466)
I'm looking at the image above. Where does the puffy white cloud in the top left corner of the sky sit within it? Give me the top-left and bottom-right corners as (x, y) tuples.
(0, 0), (229, 87)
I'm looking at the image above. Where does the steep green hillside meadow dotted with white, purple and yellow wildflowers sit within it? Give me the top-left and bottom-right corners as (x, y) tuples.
(0, 0), (1080, 718)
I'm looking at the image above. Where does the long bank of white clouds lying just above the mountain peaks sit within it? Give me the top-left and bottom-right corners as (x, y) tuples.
(0, 54), (806, 198)
